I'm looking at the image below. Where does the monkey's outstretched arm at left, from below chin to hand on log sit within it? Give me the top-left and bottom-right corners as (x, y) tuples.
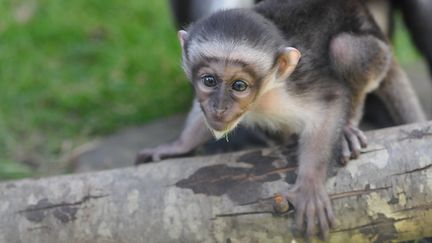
(135, 101), (211, 164)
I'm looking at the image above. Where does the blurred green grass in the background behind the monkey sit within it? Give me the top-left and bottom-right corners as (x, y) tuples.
(0, 0), (419, 180)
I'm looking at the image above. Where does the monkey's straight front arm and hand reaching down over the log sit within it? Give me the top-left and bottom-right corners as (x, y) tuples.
(287, 101), (344, 238)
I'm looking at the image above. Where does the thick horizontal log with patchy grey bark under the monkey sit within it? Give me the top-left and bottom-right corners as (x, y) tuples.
(0, 122), (432, 243)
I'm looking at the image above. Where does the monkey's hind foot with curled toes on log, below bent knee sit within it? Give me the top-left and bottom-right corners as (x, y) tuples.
(340, 125), (367, 165)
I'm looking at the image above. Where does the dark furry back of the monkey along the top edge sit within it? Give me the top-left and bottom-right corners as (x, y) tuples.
(255, 0), (384, 49)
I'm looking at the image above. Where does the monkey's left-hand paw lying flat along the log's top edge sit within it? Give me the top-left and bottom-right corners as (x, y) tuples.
(135, 140), (190, 164)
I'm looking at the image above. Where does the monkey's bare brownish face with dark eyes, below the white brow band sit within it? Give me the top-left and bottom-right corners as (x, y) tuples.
(193, 60), (259, 138)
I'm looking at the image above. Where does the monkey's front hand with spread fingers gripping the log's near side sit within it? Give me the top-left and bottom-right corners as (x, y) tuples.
(286, 177), (336, 239)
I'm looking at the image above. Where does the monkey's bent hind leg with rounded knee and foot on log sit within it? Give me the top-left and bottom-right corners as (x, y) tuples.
(330, 33), (391, 164)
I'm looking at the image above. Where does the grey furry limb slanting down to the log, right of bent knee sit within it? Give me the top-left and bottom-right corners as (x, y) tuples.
(376, 60), (426, 124)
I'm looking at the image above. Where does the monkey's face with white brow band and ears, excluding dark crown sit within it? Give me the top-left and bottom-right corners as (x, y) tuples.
(178, 31), (300, 138)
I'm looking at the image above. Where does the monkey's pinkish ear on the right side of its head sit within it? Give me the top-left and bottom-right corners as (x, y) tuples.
(277, 47), (301, 79)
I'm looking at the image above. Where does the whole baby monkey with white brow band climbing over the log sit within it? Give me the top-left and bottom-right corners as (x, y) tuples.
(137, 0), (425, 238)
